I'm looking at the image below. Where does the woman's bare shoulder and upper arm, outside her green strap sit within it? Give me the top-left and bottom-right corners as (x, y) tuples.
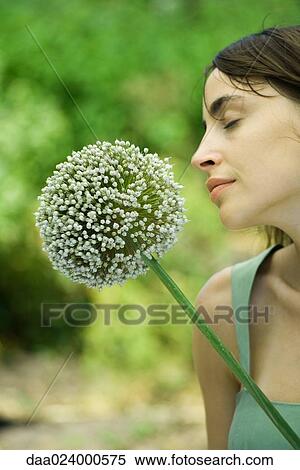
(192, 266), (240, 449)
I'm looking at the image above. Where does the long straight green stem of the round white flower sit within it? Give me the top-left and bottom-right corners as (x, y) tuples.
(141, 253), (300, 449)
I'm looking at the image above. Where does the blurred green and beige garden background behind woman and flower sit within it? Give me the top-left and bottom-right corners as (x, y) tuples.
(0, 0), (300, 449)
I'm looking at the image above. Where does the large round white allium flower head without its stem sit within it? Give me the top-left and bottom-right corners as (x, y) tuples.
(34, 140), (188, 289)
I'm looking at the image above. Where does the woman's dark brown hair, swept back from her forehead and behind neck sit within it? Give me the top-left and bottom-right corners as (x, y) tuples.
(203, 25), (300, 247)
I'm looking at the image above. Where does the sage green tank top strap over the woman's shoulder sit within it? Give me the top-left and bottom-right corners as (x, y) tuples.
(231, 243), (283, 374)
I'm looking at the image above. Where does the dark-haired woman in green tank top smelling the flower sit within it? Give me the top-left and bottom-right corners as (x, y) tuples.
(191, 25), (300, 449)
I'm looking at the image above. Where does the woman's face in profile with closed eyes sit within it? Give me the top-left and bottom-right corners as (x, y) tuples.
(191, 69), (300, 231)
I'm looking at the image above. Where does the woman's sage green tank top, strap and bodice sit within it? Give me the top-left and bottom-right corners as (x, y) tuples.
(228, 244), (300, 450)
